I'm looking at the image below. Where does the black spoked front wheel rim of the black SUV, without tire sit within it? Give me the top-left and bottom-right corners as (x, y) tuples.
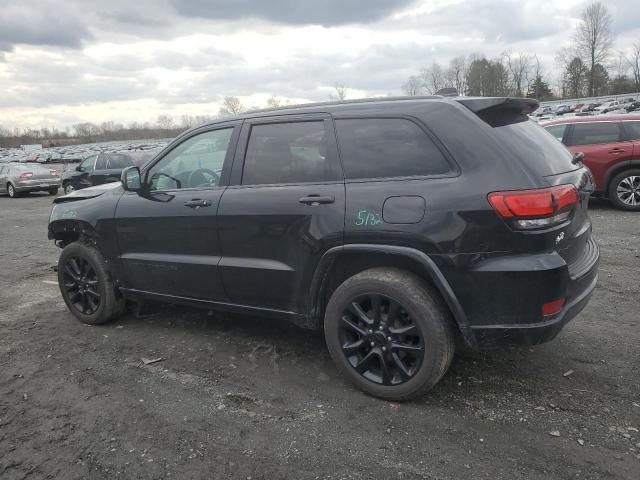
(61, 257), (102, 315)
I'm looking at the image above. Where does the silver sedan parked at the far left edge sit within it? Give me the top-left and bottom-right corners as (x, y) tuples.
(0, 163), (60, 198)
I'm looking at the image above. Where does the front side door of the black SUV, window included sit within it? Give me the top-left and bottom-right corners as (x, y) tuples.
(115, 122), (239, 301)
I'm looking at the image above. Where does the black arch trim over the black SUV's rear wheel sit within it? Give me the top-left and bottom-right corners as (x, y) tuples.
(308, 244), (476, 347)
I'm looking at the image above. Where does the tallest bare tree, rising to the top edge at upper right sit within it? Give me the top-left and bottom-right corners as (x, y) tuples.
(575, 2), (613, 96)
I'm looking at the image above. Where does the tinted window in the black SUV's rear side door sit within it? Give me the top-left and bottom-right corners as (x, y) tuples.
(242, 120), (340, 185)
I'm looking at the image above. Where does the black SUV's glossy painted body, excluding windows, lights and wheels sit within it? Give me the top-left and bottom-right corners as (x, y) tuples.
(49, 98), (598, 347)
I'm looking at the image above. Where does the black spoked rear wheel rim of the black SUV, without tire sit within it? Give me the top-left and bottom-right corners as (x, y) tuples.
(338, 293), (425, 386)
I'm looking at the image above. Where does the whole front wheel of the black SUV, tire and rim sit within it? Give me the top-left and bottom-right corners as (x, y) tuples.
(58, 241), (125, 325)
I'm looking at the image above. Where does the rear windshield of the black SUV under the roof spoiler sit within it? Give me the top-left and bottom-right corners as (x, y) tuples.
(479, 112), (578, 175)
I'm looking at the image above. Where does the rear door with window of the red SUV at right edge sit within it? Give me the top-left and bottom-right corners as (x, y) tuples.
(567, 121), (633, 192)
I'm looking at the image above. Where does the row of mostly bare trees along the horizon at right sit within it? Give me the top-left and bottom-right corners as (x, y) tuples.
(402, 2), (640, 101)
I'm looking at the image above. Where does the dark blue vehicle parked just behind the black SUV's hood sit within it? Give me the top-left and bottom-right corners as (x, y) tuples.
(62, 151), (153, 193)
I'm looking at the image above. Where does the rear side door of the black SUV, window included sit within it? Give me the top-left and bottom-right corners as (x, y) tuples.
(218, 115), (345, 313)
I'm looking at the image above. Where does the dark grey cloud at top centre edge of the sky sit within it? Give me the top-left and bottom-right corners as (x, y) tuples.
(171, 0), (414, 26)
